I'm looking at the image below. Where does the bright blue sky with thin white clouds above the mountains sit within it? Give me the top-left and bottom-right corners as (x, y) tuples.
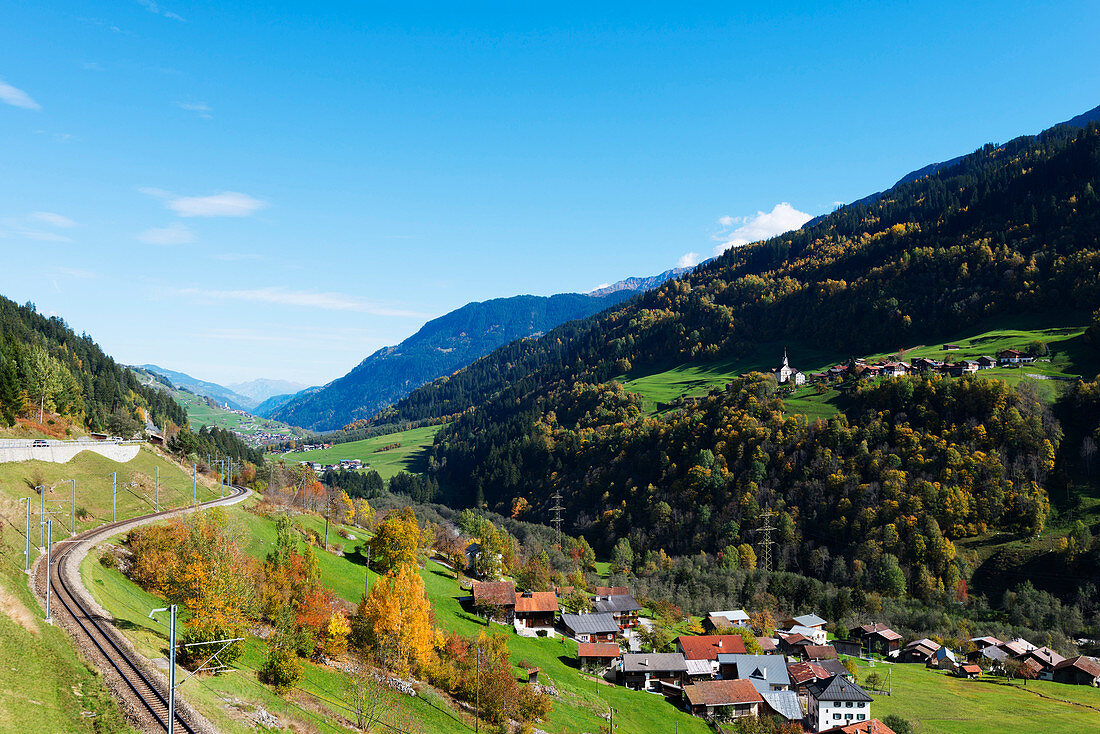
(0, 0), (1100, 383)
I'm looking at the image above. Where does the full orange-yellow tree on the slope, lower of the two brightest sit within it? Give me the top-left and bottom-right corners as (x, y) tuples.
(352, 563), (442, 676)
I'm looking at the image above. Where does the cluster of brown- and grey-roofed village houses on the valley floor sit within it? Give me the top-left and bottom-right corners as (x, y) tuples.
(462, 559), (1100, 734)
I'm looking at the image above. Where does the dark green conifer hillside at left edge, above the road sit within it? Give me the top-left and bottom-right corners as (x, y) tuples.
(0, 296), (187, 430)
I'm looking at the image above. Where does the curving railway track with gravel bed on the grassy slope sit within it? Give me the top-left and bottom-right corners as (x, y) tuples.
(40, 486), (249, 734)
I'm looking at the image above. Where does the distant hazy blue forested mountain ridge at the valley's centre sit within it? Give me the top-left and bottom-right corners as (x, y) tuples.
(270, 290), (638, 430)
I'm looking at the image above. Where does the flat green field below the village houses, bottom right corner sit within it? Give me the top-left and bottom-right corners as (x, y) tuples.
(859, 665), (1100, 734)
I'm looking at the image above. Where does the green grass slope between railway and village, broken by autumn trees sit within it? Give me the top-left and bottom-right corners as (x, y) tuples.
(83, 501), (708, 734)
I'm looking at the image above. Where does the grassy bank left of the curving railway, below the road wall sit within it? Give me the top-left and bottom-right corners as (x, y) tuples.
(0, 450), (221, 734)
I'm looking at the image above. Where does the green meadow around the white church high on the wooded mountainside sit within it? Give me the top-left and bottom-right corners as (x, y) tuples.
(622, 314), (1100, 420)
